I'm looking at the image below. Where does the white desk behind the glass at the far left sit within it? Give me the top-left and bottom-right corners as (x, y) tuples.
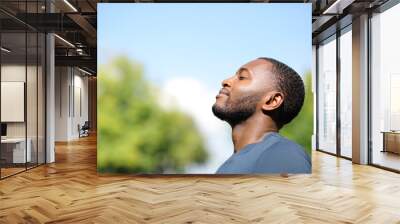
(1, 138), (32, 163)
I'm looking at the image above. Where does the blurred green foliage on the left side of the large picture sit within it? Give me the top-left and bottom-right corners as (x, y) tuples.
(97, 57), (208, 173)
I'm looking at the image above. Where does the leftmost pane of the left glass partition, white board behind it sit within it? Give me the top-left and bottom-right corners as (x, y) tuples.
(0, 32), (27, 177)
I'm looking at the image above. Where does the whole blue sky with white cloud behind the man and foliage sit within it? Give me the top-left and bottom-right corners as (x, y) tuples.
(97, 3), (311, 173)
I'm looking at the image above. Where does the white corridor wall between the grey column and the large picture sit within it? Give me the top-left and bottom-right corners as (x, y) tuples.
(55, 67), (88, 141)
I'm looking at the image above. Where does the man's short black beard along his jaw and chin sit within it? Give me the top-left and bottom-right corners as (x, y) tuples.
(212, 95), (262, 127)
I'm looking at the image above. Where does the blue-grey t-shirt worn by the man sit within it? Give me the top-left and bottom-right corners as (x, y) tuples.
(216, 132), (311, 174)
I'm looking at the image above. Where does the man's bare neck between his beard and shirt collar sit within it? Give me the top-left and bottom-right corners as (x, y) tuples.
(232, 115), (278, 153)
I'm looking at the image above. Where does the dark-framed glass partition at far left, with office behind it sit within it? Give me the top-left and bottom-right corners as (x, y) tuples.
(0, 1), (46, 179)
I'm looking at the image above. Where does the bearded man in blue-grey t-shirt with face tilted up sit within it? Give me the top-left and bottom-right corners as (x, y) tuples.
(212, 58), (311, 174)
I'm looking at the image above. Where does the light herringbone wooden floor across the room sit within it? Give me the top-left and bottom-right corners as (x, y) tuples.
(0, 134), (400, 224)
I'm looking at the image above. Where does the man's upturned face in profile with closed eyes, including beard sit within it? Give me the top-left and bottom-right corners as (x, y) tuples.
(212, 59), (274, 125)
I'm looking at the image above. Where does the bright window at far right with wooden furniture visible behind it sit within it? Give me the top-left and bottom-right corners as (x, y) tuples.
(370, 1), (400, 170)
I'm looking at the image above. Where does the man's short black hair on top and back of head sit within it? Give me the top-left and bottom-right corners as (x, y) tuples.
(258, 57), (305, 127)
